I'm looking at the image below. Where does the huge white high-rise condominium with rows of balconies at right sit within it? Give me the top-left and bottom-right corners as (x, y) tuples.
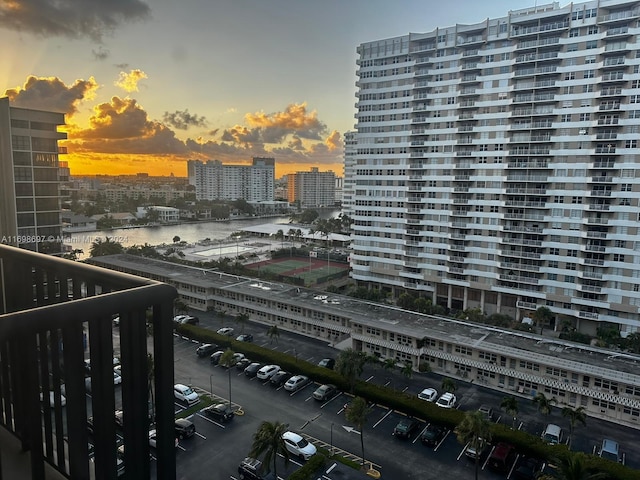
(352, 0), (640, 336)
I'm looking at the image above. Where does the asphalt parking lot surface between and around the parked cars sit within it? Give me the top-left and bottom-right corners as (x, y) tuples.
(96, 320), (637, 480)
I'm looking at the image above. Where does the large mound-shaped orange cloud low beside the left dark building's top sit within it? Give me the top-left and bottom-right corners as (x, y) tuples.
(67, 97), (188, 155)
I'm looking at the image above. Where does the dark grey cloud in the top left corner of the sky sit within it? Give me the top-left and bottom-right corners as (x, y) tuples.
(0, 0), (151, 42)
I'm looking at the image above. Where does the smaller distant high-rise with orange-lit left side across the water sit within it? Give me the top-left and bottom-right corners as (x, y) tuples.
(287, 167), (336, 208)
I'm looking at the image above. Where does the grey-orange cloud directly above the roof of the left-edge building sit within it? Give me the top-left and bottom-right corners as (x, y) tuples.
(4, 75), (98, 116)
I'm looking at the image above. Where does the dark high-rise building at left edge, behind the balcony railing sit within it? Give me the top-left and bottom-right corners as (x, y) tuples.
(0, 97), (67, 253)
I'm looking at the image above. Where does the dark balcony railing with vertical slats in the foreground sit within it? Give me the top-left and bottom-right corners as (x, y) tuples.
(0, 245), (176, 480)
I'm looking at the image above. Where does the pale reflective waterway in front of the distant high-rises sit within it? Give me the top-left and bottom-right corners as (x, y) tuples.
(65, 210), (340, 258)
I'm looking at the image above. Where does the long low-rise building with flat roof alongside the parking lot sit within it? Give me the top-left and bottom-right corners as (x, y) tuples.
(91, 255), (640, 428)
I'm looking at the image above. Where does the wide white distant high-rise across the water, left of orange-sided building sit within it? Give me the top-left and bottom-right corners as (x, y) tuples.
(187, 157), (276, 202)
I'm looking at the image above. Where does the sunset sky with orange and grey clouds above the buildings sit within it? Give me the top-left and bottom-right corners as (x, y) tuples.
(0, 0), (536, 178)
